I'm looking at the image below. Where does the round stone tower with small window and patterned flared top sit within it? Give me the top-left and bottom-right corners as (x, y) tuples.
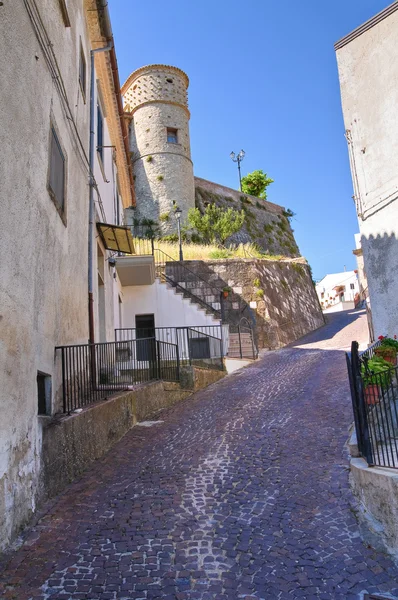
(122, 65), (195, 234)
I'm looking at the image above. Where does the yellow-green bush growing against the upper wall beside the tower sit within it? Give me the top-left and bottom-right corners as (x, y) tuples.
(188, 204), (245, 244)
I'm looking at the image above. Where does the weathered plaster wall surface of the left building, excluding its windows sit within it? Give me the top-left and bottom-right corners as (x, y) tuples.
(0, 0), (123, 550)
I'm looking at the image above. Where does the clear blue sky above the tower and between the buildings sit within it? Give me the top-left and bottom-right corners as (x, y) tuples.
(109, 0), (390, 279)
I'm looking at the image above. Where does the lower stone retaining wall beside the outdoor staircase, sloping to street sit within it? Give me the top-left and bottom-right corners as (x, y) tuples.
(167, 258), (324, 349)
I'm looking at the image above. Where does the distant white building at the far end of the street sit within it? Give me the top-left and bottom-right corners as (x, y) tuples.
(316, 271), (359, 311)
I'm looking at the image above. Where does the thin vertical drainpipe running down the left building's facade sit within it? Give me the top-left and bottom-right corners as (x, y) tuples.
(88, 41), (113, 344)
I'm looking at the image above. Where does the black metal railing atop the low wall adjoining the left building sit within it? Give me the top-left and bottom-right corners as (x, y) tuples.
(56, 338), (180, 413)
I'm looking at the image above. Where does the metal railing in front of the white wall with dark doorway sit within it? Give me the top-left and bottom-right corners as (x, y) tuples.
(115, 325), (225, 370)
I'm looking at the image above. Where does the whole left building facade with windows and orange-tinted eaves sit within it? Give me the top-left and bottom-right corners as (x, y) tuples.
(0, 0), (134, 548)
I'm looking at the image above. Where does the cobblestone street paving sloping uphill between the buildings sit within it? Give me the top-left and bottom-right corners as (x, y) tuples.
(0, 314), (398, 600)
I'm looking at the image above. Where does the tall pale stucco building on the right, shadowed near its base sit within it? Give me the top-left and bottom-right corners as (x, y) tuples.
(335, 2), (398, 338)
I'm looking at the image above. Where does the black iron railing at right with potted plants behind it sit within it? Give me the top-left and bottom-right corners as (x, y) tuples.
(346, 341), (398, 469)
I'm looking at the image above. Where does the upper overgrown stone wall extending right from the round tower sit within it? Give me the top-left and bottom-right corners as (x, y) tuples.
(195, 177), (300, 256)
